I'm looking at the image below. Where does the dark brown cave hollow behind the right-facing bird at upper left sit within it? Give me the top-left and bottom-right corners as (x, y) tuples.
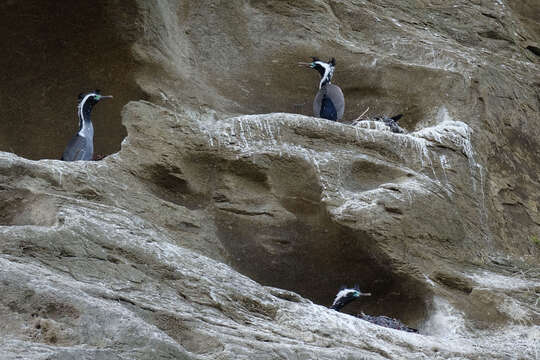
(0, 0), (144, 160)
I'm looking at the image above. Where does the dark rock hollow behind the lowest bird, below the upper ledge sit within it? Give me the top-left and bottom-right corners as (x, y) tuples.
(218, 213), (432, 328)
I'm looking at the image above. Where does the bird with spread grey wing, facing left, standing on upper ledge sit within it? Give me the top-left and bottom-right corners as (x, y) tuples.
(298, 57), (345, 121)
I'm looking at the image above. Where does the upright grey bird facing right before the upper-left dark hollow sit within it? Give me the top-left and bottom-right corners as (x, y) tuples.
(61, 90), (112, 161)
